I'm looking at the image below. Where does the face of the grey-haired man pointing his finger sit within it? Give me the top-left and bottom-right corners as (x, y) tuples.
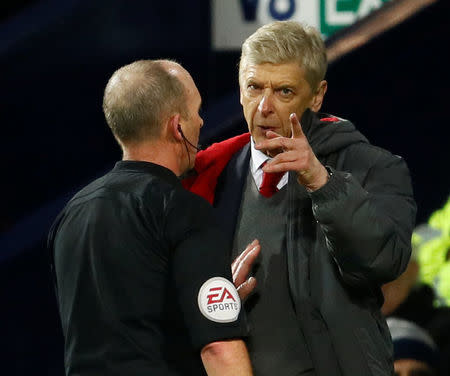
(240, 62), (314, 148)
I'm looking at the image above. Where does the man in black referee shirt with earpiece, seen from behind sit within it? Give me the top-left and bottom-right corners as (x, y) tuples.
(49, 60), (259, 376)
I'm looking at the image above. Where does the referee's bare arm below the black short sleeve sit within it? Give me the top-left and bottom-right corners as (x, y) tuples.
(201, 339), (253, 376)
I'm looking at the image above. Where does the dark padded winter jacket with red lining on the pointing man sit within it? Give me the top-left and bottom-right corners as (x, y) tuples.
(183, 111), (416, 376)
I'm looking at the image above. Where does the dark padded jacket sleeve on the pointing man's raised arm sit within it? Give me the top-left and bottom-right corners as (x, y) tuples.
(310, 144), (416, 288)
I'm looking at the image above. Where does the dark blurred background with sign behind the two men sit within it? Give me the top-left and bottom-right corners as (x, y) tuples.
(0, 0), (450, 375)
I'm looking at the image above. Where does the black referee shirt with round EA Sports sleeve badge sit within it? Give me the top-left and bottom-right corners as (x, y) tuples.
(49, 161), (245, 376)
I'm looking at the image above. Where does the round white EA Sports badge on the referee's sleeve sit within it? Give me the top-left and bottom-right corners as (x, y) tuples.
(198, 277), (241, 322)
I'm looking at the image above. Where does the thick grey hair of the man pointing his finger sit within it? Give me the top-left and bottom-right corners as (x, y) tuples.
(239, 21), (327, 90)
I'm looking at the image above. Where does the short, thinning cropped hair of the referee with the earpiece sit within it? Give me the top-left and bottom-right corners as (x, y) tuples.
(103, 60), (187, 144)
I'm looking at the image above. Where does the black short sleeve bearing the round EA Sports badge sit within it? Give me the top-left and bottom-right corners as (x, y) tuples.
(166, 192), (246, 348)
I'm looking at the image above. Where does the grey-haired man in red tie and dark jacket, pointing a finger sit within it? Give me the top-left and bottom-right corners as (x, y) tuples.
(185, 21), (416, 376)
